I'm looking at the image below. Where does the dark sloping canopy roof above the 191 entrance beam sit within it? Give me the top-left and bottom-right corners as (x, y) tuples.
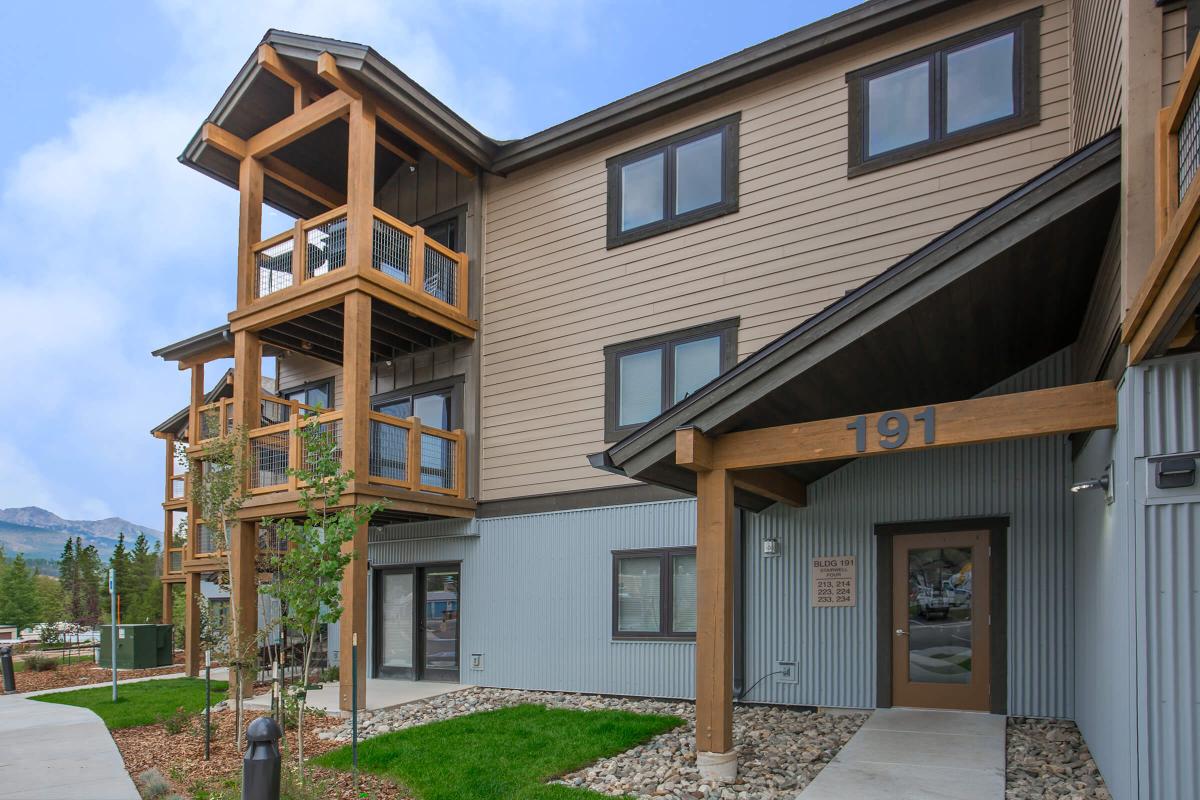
(590, 131), (1121, 491)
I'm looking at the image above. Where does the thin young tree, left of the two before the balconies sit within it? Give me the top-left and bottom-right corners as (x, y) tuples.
(190, 427), (258, 752)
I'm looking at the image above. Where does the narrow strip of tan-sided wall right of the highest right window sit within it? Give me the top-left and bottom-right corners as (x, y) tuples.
(1070, 0), (1124, 150)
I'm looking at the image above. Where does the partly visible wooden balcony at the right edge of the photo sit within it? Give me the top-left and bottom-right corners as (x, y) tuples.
(1122, 40), (1200, 363)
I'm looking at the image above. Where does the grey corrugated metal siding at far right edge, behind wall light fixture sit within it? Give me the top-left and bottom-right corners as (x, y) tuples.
(1127, 355), (1200, 800)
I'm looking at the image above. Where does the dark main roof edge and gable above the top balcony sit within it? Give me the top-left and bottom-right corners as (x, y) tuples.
(179, 0), (967, 191)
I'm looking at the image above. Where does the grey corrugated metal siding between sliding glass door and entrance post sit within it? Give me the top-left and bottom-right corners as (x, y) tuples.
(370, 500), (696, 697)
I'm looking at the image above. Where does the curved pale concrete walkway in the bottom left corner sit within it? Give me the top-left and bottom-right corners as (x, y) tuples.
(0, 694), (138, 800)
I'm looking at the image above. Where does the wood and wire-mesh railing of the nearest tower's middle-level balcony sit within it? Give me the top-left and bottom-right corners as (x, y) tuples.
(247, 411), (467, 498)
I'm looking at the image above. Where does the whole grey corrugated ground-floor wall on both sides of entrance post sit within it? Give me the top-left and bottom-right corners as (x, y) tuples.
(370, 353), (1074, 717)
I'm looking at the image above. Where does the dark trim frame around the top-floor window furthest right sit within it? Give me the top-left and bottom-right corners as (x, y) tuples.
(846, 6), (1043, 178)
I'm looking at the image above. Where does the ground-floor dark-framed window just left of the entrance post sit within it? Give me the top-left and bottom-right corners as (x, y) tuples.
(612, 547), (696, 639)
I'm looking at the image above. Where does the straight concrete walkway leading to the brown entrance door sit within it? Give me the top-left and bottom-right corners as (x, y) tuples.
(800, 709), (1006, 800)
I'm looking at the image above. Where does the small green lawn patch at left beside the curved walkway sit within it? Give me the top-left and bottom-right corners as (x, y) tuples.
(30, 678), (226, 730)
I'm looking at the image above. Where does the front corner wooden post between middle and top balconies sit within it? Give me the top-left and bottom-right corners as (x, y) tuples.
(342, 291), (371, 491)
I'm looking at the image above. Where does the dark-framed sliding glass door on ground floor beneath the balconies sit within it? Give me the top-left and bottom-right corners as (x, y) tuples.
(376, 564), (461, 681)
